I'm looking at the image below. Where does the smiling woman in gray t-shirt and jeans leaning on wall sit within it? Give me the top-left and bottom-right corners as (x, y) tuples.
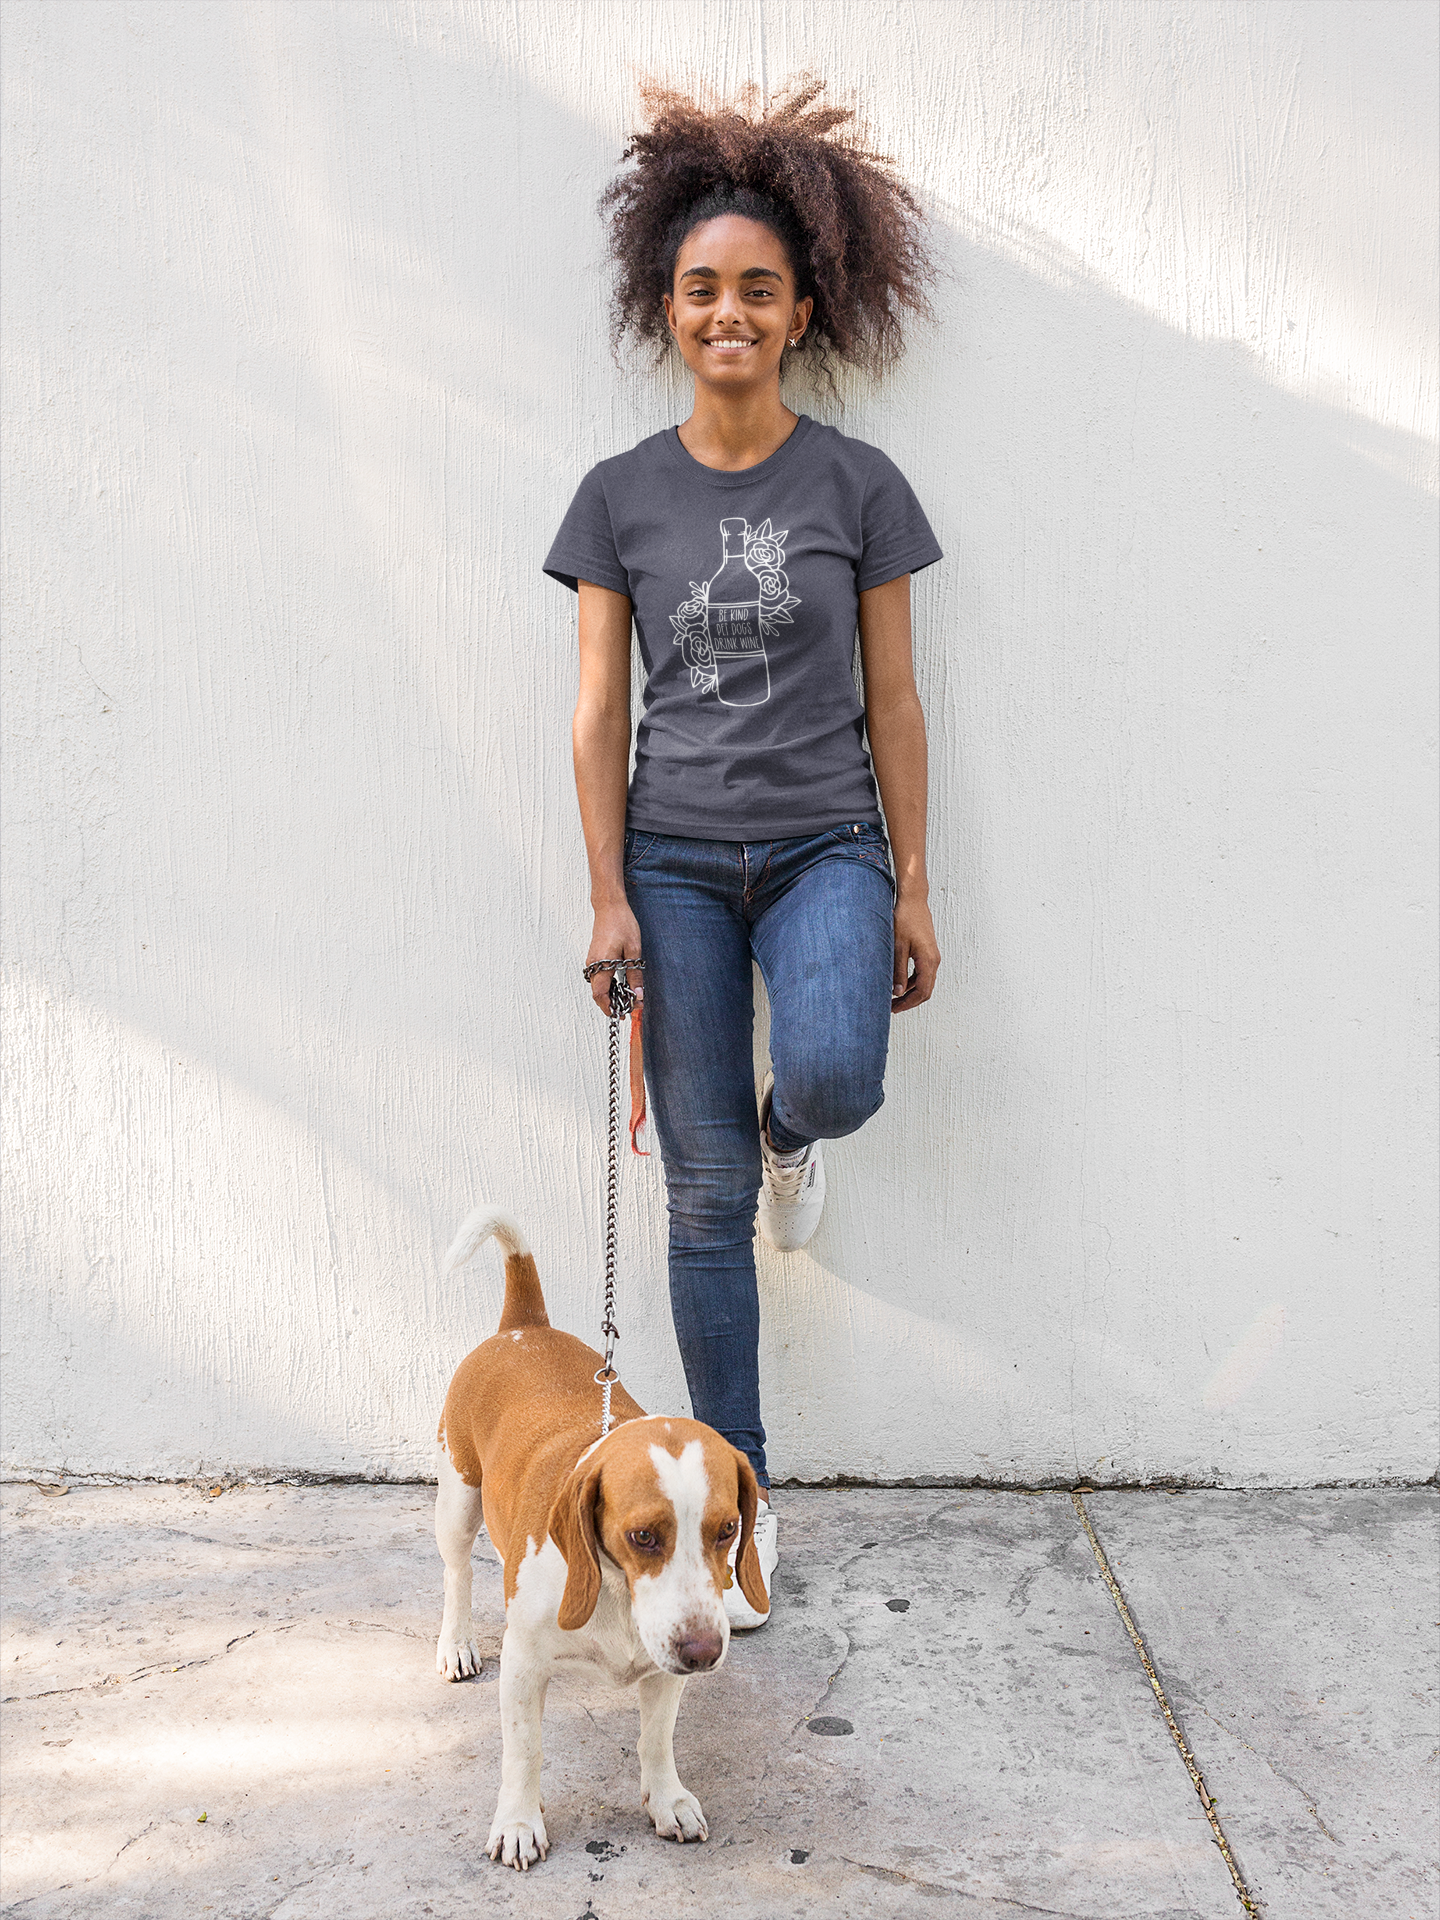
(545, 83), (941, 1626)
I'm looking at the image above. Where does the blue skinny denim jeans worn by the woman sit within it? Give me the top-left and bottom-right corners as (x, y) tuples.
(624, 822), (895, 1486)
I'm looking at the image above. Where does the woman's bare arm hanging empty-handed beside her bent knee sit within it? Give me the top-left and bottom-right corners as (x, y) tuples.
(860, 574), (941, 1014)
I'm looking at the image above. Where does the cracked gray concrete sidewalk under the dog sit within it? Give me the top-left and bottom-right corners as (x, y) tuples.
(0, 1486), (1440, 1920)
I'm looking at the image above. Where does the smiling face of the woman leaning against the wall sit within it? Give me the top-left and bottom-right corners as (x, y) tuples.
(664, 213), (812, 392)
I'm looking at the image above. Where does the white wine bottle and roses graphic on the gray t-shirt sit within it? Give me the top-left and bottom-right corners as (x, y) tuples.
(670, 515), (801, 707)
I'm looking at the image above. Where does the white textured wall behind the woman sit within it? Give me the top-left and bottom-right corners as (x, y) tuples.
(4, 0), (1436, 1484)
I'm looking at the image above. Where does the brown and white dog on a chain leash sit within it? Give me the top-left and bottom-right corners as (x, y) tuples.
(436, 1206), (770, 1872)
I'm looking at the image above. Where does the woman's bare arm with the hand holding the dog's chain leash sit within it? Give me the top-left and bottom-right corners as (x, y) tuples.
(570, 580), (643, 1014)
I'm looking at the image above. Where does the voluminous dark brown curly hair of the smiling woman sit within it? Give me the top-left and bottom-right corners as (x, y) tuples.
(599, 75), (935, 374)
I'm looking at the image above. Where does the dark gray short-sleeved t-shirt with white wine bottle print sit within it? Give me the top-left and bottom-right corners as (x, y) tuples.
(545, 415), (941, 841)
